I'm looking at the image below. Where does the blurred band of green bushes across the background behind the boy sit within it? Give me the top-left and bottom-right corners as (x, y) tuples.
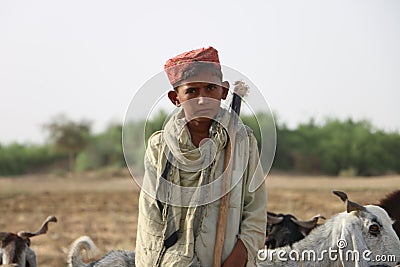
(0, 111), (400, 176)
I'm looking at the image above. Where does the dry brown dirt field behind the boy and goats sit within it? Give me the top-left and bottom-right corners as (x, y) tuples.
(0, 174), (400, 267)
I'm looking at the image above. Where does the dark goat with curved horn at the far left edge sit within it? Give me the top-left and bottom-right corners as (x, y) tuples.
(0, 216), (57, 267)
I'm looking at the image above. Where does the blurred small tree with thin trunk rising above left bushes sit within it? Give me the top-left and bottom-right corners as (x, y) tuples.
(44, 115), (91, 173)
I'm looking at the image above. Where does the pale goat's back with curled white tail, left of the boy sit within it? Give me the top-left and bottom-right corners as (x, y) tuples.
(68, 236), (135, 267)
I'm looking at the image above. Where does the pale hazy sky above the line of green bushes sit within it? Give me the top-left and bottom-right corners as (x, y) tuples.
(0, 0), (400, 143)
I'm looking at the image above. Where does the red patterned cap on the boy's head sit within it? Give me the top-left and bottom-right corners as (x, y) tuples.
(164, 46), (221, 84)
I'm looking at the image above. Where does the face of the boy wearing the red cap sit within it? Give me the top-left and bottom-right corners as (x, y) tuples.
(168, 70), (229, 122)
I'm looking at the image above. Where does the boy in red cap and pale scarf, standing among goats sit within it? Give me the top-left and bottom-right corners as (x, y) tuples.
(135, 47), (266, 267)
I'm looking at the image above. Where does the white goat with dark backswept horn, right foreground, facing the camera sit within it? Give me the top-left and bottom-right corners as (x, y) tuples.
(257, 191), (400, 266)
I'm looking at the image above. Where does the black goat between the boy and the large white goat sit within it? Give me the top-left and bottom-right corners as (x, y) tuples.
(265, 211), (325, 249)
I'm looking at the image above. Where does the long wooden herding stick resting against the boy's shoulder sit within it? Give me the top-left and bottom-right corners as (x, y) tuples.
(213, 81), (248, 267)
